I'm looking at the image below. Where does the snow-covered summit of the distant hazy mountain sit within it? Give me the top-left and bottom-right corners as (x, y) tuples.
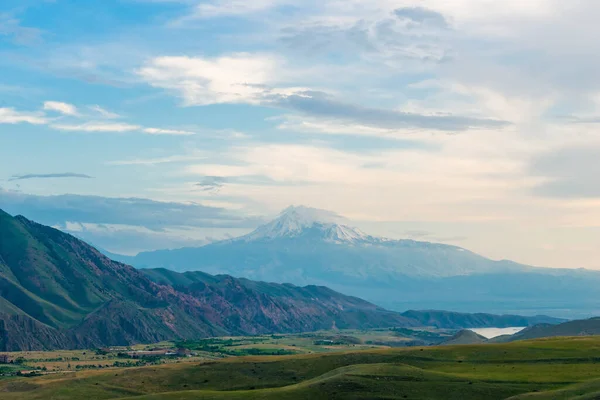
(241, 206), (373, 243)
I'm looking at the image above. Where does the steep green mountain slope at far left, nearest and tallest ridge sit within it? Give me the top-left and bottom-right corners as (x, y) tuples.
(0, 211), (230, 349)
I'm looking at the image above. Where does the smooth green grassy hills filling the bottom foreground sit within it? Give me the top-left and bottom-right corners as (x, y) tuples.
(0, 337), (600, 400)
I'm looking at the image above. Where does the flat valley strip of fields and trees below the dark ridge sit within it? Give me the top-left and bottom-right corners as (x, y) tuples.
(0, 329), (450, 373)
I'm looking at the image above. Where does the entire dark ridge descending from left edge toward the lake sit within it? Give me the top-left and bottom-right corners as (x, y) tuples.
(0, 211), (560, 351)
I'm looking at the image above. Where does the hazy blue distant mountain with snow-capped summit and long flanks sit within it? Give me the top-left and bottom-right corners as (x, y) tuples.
(124, 207), (600, 318)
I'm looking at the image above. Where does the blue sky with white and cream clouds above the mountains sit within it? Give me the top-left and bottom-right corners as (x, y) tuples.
(0, 0), (600, 268)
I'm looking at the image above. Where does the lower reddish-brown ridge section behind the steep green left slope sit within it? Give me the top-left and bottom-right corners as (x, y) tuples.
(144, 269), (418, 334)
